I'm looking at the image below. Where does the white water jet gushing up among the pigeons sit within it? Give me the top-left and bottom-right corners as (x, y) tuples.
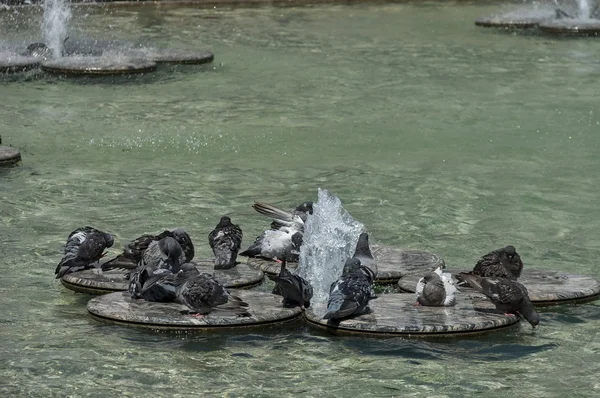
(298, 188), (364, 307)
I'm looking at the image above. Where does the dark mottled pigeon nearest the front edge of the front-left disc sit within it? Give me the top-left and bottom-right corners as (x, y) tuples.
(176, 274), (250, 317)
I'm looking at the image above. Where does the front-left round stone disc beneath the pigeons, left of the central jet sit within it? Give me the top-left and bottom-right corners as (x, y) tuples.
(87, 290), (302, 331)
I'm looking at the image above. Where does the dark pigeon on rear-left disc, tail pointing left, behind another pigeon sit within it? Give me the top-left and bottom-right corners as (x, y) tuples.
(102, 228), (195, 271)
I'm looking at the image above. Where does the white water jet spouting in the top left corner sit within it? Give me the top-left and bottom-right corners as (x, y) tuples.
(42, 0), (71, 57)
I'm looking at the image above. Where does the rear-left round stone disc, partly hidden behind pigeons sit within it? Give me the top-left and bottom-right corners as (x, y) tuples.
(60, 260), (264, 294)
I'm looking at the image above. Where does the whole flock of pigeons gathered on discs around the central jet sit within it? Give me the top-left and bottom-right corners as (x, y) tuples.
(55, 202), (539, 327)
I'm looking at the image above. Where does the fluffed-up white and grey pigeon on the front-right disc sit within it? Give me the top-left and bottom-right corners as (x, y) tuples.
(416, 267), (457, 306)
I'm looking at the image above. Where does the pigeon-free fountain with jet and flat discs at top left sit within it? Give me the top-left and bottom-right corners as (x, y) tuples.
(0, 0), (214, 76)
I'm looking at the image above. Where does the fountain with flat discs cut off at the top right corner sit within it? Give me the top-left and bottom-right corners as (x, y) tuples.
(475, 0), (600, 36)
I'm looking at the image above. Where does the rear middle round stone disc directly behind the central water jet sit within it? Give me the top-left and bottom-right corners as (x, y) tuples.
(247, 245), (444, 284)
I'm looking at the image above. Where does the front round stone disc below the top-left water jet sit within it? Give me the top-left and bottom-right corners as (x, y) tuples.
(42, 57), (156, 76)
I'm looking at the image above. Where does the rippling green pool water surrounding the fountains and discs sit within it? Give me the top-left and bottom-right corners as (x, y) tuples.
(0, 3), (600, 397)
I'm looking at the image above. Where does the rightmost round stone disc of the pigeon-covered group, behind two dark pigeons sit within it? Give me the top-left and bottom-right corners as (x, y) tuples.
(398, 269), (600, 306)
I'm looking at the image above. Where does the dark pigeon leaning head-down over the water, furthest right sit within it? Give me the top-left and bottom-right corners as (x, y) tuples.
(460, 272), (540, 328)
